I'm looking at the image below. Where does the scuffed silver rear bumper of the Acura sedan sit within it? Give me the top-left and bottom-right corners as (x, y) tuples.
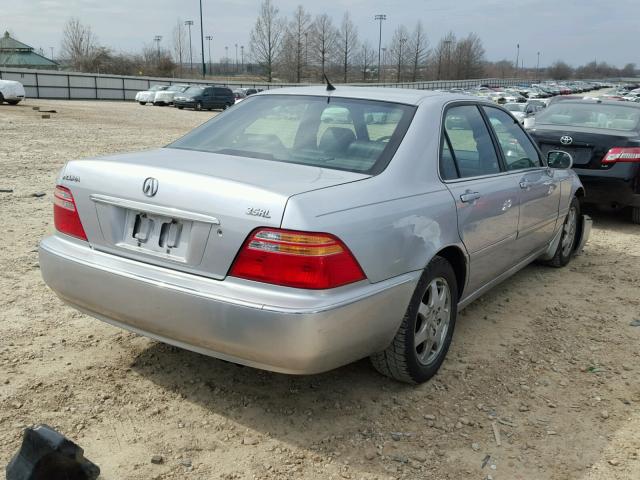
(39, 235), (420, 374)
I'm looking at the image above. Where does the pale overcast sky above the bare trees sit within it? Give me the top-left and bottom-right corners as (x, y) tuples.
(5, 0), (640, 66)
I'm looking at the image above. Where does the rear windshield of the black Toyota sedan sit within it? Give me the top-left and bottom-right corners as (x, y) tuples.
(536, 102), (640, 131)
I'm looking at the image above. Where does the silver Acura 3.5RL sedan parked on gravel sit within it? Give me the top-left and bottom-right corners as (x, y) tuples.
(40, 87), (591, 383)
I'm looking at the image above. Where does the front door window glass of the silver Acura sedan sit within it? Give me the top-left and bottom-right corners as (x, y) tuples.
(482, 107), (542, 170)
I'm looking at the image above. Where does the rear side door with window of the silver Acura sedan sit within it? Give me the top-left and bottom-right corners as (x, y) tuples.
(440, 104), (520, 292)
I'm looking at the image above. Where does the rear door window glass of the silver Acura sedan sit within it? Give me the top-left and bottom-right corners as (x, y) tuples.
(443, 105), (500, 178)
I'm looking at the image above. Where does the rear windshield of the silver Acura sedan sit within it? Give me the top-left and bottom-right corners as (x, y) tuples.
(169, 95), (415, 175)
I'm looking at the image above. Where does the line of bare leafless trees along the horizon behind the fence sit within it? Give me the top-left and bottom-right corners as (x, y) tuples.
(61, 9), (638, 83)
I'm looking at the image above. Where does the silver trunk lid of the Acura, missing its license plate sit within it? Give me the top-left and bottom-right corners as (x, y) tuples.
(62, 148), (369, 279)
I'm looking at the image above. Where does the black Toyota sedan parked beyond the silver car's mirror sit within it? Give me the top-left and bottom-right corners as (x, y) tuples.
(530, 100), (640, 223)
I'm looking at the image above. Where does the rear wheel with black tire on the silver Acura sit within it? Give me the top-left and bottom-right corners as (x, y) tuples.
(371, 256), (458, 384)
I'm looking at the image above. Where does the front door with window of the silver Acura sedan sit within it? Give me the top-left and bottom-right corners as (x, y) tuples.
(482, 106), (561, 258)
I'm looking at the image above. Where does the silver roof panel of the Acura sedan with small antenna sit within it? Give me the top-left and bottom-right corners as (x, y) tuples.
(258, 85), (470, 105)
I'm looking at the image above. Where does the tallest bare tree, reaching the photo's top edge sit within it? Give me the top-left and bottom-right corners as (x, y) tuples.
(250, 0), (285, 82)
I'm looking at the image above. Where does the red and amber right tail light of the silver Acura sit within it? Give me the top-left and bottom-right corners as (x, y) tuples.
(229, 228), (366, 290)
